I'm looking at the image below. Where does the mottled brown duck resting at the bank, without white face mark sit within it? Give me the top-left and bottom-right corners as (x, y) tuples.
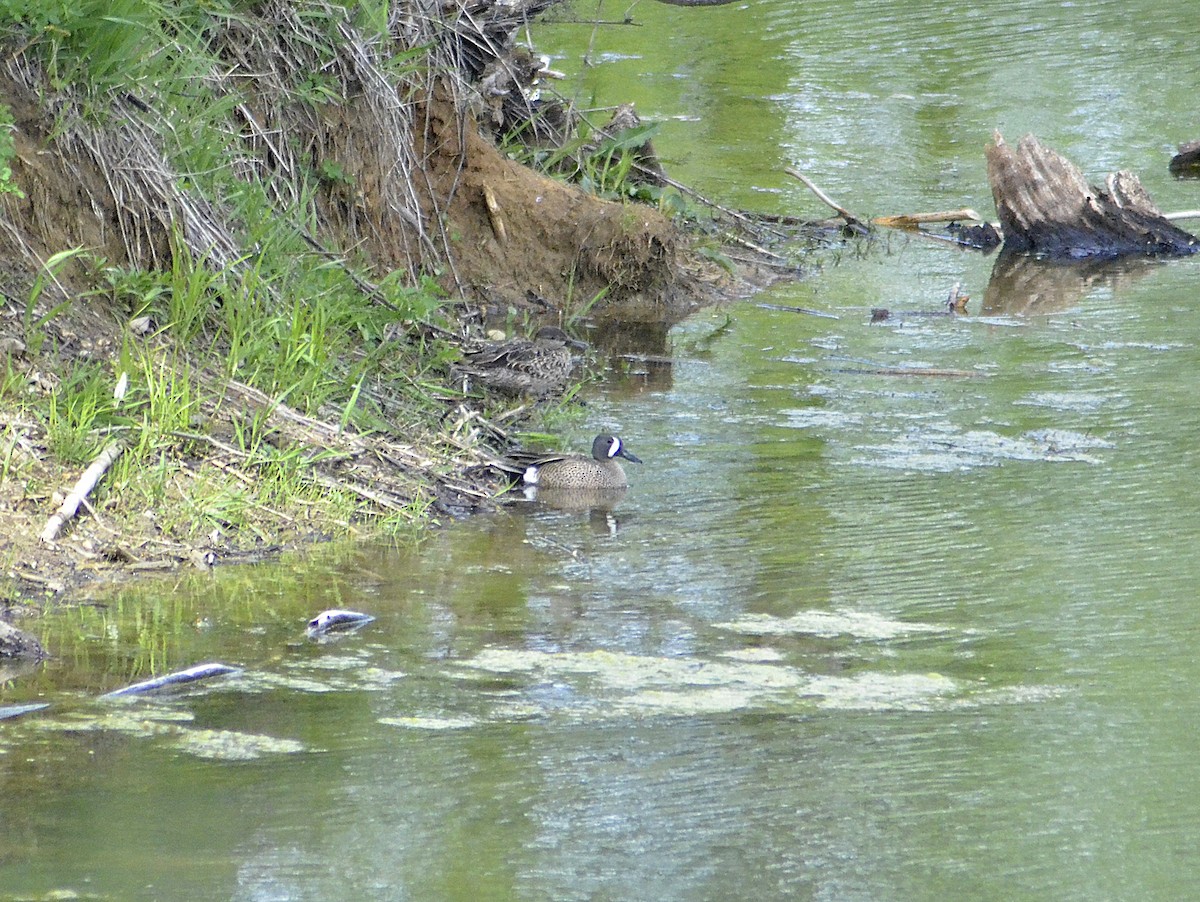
(457, 326), (587, 397)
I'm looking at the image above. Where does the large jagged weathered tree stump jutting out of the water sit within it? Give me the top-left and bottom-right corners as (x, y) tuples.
(986, 132), (1200, 259)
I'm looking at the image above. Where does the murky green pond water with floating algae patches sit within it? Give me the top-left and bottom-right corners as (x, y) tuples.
(7, 2), (1200, 900)
